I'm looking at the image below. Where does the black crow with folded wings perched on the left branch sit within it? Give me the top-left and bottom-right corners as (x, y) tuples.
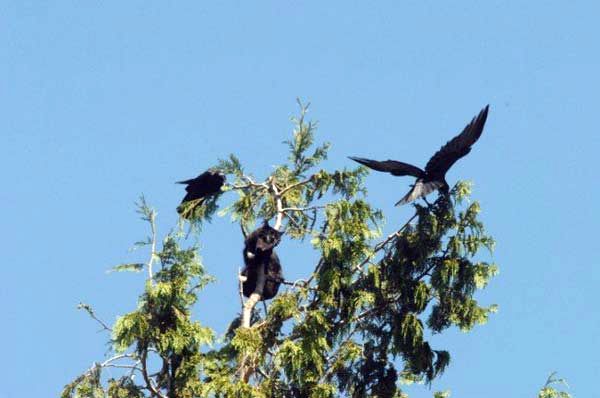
(177, 170), (225, 218)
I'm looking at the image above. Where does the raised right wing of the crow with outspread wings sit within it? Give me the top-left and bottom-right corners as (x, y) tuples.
(425, 105), (490, 178)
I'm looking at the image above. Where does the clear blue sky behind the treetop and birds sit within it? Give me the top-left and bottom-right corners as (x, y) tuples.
(0, 1), (600, 398)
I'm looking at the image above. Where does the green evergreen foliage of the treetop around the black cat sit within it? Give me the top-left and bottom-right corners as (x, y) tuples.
(63, 103), (498, 398)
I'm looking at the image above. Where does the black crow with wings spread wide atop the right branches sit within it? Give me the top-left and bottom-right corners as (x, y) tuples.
(350, 105), (489, 206)
